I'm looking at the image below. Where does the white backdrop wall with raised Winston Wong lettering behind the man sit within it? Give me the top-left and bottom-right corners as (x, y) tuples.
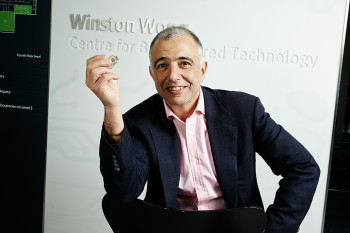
(44, 0), (348, 233)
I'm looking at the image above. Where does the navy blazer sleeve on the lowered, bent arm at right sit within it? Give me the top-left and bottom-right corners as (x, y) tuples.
(253, 98), (320, 233)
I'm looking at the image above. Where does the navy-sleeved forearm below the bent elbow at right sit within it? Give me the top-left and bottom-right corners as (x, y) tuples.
(266, 154), (320, 233)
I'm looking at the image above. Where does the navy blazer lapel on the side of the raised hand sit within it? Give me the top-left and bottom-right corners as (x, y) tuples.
(150, 102), (180, 208)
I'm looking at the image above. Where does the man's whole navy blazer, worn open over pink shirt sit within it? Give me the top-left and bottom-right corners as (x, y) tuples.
(100, 87), (320, 233)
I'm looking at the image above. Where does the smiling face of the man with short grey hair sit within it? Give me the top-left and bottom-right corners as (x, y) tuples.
(150, 35), (207, 114)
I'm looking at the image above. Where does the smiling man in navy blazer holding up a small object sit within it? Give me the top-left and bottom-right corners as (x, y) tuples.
(86, 27), (320, 233)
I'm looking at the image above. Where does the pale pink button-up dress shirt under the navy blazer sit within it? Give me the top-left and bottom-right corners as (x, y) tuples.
(164, 89), (226, 210)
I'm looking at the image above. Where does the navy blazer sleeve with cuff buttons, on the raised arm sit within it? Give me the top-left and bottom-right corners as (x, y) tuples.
(99, 125), (149, 202)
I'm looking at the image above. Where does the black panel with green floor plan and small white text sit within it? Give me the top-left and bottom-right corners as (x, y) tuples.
(0, 0), (51, 232)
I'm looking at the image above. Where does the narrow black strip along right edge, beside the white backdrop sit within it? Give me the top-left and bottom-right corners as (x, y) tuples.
(323, 5), (350, 233)
